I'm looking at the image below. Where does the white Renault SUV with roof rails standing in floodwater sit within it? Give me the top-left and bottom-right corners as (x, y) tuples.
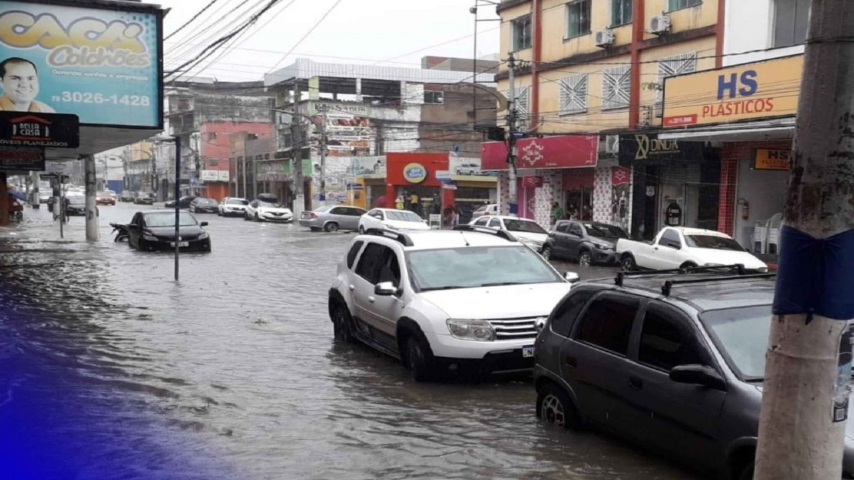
(329, 225), (578, 381)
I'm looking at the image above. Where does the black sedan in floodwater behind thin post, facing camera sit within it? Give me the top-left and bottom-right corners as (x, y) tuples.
(127, 210), (211, 252)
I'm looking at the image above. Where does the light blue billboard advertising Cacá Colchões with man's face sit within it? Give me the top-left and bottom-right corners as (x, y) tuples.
(0, 1), (162, 128)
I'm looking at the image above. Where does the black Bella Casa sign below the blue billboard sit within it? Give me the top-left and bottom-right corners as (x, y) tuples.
(0, 111), (80, 148)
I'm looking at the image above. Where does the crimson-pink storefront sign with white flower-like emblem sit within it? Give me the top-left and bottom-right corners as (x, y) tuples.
(481, 135), (599, 170)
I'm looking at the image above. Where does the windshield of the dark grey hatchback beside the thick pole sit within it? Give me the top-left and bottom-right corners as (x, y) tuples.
(700, 305), (772, 380)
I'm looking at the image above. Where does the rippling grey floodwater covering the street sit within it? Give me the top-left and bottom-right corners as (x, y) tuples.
(0, 203), (696, 480)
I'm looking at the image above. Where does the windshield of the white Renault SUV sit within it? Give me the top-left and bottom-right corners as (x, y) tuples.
(408, 246), (562, 291)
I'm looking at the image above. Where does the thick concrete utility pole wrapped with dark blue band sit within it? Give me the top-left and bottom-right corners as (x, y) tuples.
(756, 0), (854, 480)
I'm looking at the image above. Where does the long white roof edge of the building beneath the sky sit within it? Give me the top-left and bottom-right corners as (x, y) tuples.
(264, 58), (495, 87)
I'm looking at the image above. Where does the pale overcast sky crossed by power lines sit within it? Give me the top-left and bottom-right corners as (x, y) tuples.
(162, 0), (499, 81)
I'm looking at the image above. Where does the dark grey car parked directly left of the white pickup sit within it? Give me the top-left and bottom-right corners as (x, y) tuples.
(543, 220), (629, 267)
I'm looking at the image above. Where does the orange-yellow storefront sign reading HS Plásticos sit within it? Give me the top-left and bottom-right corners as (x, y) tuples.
(663, 55), (804, 127)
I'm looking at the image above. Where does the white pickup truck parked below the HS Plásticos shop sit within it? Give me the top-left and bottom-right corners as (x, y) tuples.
(616, 227), (768, 272)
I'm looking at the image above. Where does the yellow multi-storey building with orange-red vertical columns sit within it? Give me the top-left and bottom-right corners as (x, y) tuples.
(496, 0), (724, 235)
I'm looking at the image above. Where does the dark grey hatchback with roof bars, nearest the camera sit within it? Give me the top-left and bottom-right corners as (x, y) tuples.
(534, 273), (854, 480)
